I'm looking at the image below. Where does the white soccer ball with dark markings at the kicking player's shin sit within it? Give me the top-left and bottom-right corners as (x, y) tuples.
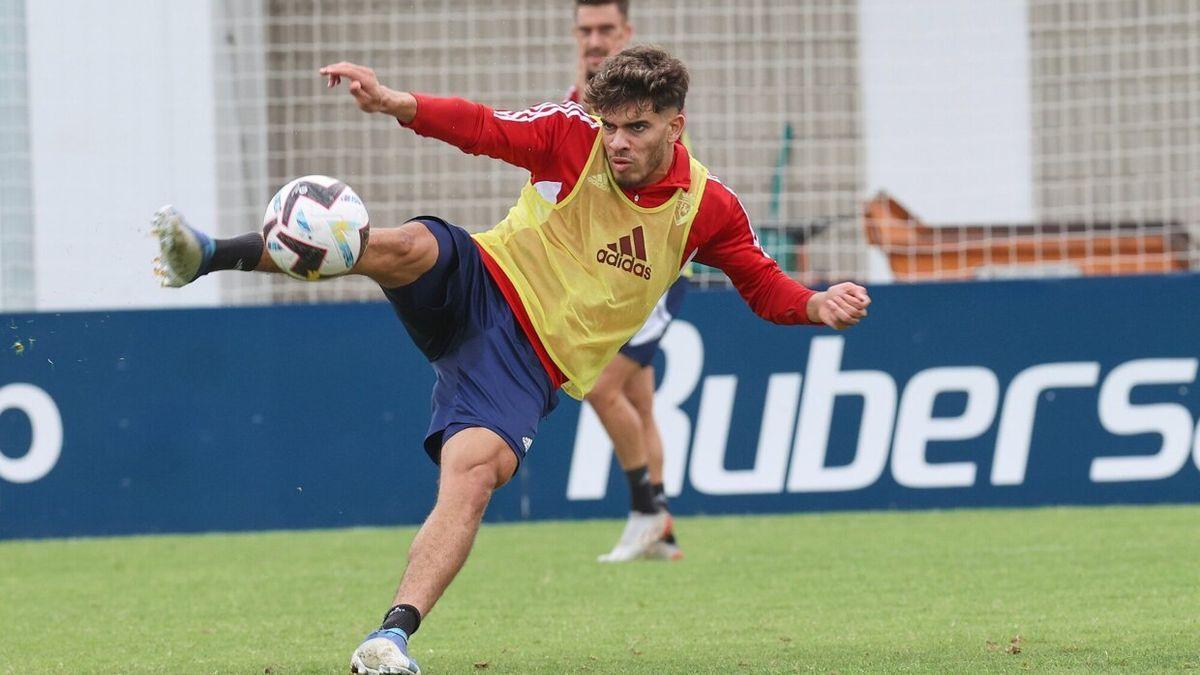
(263, 175), (371, 281)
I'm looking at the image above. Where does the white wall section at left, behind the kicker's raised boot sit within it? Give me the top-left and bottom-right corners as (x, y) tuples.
(25, 0), (217, 310)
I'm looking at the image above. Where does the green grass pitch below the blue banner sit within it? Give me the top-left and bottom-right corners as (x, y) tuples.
(0, 507), (1200, 675)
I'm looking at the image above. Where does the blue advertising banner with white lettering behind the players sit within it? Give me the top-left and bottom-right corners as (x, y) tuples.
(0, 275), (1200, 538)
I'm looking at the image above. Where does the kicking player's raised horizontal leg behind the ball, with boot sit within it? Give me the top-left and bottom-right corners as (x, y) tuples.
(151, 207), (438, 288)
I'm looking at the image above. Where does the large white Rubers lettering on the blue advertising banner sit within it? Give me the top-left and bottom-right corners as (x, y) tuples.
(568, 331), (1200, 500)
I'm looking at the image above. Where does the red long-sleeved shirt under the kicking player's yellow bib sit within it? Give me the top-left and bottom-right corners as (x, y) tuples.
(407, 94), (814, 387)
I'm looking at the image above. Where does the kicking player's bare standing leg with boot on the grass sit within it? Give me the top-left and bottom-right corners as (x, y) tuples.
(350, 426), (517, 675)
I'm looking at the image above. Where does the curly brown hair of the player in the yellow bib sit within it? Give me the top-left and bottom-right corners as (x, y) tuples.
(584, 44), (689, 113)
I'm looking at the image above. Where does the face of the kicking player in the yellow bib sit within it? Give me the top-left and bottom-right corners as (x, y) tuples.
(600, 103), (684, 189)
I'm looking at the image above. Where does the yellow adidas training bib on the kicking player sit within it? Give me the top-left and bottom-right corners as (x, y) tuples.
(474, 133), (708, 399)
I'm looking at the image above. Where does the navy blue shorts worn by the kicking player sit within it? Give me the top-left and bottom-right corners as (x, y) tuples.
(383, 216), (558, 464)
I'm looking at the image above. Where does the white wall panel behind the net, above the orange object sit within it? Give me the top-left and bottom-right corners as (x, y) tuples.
(859, 0), (1033, 225)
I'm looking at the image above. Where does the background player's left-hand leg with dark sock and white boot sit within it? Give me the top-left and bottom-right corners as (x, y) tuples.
(587, 354), (670, 562)
